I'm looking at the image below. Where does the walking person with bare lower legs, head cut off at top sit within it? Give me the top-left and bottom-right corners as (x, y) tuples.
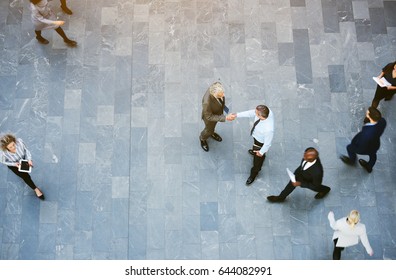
(30, 0), (77, 47)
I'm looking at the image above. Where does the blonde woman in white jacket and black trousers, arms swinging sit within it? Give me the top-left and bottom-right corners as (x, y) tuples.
(328, 210), (374, 260)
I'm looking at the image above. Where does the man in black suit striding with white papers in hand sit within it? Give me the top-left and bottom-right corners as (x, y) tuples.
(267, 147), (331, 202)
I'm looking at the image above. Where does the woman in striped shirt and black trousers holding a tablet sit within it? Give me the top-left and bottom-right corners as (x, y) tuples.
(0, 134), (44, 200)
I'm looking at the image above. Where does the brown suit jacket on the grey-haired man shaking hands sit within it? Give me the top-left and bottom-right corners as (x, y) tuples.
(202, 89), (226, 122)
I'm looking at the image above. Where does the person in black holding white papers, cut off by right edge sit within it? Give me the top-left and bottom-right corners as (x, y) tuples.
(371, 61), (396, 108)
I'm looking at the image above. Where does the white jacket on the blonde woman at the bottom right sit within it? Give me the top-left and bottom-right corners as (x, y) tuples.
(328, 212), (373, 255)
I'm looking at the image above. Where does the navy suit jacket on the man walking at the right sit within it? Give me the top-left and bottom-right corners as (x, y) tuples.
(351, 118), (386, 154)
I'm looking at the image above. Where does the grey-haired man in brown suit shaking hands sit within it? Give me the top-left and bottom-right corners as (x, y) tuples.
(199, 82), (235, 152)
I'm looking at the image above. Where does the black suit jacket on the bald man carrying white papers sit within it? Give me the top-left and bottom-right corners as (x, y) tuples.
(294, 158), (323, 189)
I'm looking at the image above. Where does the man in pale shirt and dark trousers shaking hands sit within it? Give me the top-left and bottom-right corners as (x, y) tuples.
(234, 105), (274, 186)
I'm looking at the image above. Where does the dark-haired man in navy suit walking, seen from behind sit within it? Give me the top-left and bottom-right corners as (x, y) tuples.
(340, 107), (386, 173)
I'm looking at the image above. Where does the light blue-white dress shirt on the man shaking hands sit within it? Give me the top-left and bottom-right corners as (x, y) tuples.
(237, 109), (274, 155)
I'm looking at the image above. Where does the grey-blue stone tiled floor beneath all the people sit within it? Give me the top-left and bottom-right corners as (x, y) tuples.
(0, 0), (396, 259)
